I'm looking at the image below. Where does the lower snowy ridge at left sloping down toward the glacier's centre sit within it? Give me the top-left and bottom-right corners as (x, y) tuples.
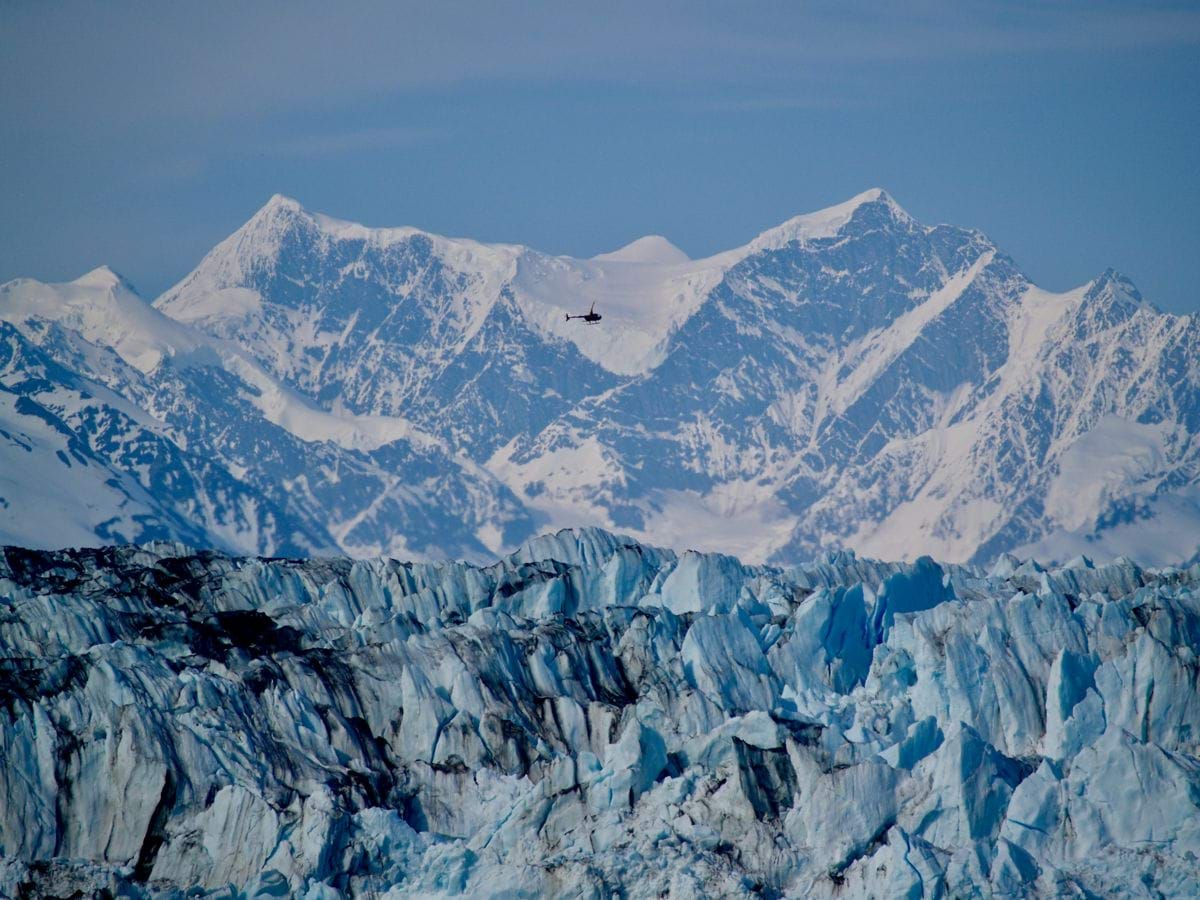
(0, 270), (530, 558)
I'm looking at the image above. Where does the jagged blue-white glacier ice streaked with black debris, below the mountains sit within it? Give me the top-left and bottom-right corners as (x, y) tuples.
(0, 528), (1200, 898)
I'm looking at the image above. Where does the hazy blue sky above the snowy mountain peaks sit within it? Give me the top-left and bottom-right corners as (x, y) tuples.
(7, 2), (1200, 312)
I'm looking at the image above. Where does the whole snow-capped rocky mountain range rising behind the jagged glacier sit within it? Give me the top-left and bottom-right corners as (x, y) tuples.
(0, 190), (1200, 564)
